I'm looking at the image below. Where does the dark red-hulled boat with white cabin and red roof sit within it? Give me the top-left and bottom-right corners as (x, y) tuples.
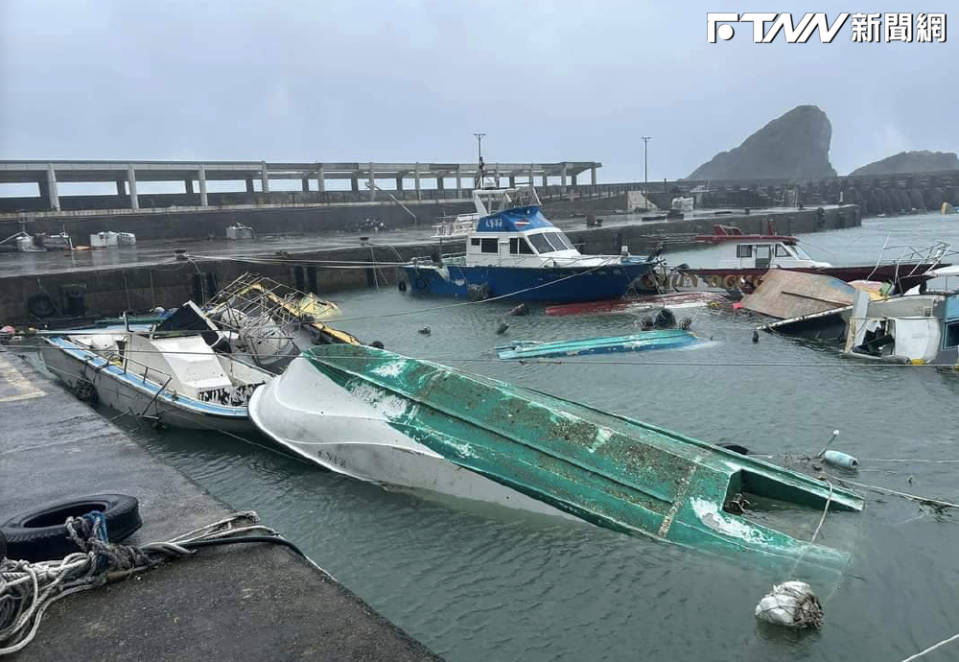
(683, 221), (949, 293)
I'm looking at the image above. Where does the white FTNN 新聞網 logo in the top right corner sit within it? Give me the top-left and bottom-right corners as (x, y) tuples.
(706, 12), (946, 44)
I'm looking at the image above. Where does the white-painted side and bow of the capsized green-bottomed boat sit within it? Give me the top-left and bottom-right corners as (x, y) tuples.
(249, 357), (575, 519)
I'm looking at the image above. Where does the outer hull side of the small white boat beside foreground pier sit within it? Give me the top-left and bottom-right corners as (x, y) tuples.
(41, 344), (255, 433)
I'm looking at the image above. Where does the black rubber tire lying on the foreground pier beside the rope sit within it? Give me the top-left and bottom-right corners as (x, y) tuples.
(0, 494), (143, 563)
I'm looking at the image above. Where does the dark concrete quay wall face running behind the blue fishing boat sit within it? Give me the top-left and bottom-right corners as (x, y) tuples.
(0, 205), (861, 326)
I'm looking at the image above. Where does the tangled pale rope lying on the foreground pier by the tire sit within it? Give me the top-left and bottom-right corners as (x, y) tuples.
(0, 510), (302, 656)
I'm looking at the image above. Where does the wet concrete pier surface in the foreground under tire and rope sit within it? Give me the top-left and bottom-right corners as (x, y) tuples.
(0, 348), (440, 662)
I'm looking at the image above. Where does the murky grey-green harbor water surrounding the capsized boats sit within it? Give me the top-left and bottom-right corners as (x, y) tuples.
(37, 215), (959, 662)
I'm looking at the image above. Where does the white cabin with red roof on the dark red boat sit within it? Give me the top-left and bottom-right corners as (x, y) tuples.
(696, 221), (831, 269)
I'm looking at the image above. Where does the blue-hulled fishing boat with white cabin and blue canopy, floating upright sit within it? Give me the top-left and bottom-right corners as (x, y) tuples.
(402, 187), (661, 303)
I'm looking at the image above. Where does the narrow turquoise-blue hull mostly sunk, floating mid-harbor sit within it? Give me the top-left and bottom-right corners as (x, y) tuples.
(496, 329), (699, 360)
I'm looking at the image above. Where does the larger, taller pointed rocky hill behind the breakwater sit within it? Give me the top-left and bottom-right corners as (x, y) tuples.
(688, 106), (836, 180)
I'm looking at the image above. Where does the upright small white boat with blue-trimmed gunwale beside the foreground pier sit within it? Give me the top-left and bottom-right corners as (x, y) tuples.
(41, 329), (273, 432)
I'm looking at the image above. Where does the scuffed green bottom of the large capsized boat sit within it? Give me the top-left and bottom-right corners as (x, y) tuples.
(303, 345), (863, 569)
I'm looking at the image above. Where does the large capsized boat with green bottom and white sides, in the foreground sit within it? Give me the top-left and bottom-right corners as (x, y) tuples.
(250, 345), (863, 569)
